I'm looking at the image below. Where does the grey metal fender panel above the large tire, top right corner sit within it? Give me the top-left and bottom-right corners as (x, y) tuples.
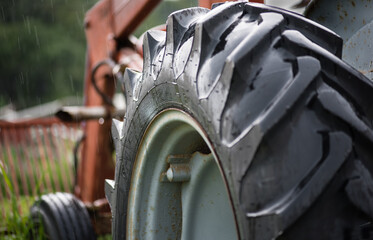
(305, 0), (373, 80)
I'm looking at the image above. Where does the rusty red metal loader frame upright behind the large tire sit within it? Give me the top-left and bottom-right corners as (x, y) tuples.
(79, 0), (160, 202)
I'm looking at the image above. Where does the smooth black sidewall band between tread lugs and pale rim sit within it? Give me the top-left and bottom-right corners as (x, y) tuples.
(113, 79), (236, 239)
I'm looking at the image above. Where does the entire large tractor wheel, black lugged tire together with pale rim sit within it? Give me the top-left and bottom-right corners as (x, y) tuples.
(106, 2), (373, 240)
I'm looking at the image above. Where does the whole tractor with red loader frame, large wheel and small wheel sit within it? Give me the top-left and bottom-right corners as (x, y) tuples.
(32, 0), (373, 240)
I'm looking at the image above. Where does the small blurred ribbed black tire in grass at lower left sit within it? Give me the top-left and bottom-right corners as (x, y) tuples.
(30, 193), (96, 240)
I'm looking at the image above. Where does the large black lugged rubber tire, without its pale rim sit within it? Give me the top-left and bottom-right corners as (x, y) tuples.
(112, 2), (373, 240)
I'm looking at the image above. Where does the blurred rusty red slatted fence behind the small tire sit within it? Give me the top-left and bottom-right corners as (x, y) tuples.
(0, 117), (77, 216)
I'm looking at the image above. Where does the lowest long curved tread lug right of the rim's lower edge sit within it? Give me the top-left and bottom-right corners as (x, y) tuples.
(246, 132), (352, 239)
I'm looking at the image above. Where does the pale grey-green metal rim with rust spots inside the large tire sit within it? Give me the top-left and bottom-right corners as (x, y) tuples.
(126, 109), (238, 239)
